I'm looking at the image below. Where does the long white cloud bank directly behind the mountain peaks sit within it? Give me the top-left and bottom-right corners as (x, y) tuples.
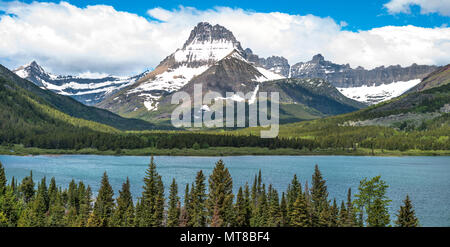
(0, 2), (450, 75)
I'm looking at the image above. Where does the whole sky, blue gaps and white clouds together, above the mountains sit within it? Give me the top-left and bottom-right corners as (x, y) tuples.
(0, 0), (450, 75)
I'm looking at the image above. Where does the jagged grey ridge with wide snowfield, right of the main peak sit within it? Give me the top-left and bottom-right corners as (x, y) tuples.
(291, 54), (437, 104)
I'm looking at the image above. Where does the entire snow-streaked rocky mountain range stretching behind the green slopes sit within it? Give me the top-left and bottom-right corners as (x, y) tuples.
(9, 22), (437, 127)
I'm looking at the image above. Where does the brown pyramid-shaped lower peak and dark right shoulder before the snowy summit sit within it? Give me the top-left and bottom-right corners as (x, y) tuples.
(149, 50), (366, 123)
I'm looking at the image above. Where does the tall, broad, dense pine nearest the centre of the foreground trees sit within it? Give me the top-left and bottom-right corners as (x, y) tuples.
(207, 160), (233, 226)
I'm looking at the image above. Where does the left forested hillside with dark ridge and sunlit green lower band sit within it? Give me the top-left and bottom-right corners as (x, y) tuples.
(0, 62), (155, 131)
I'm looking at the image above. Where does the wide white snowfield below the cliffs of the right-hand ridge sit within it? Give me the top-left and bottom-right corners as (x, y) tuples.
(337, 79), (421, 104)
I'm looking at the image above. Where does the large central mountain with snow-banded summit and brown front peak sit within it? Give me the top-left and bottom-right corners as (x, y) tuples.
(98, 23), (365, 122)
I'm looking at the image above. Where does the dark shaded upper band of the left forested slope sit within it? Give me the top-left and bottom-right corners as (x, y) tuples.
(0, 65), (155, 130)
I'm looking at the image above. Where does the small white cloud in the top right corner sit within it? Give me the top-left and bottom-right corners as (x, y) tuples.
(384, 0), (450, 16)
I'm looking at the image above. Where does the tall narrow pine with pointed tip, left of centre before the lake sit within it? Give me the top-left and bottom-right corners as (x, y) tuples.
(139, 156), (164, 227)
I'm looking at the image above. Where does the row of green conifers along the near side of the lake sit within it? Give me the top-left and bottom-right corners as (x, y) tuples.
(0, 157), (419, 227)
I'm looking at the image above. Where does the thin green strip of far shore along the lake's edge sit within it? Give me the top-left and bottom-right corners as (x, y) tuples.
(0, 145), (450, 157)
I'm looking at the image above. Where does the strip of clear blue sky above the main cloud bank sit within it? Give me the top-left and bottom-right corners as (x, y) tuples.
(6, 0), (450, 30)
